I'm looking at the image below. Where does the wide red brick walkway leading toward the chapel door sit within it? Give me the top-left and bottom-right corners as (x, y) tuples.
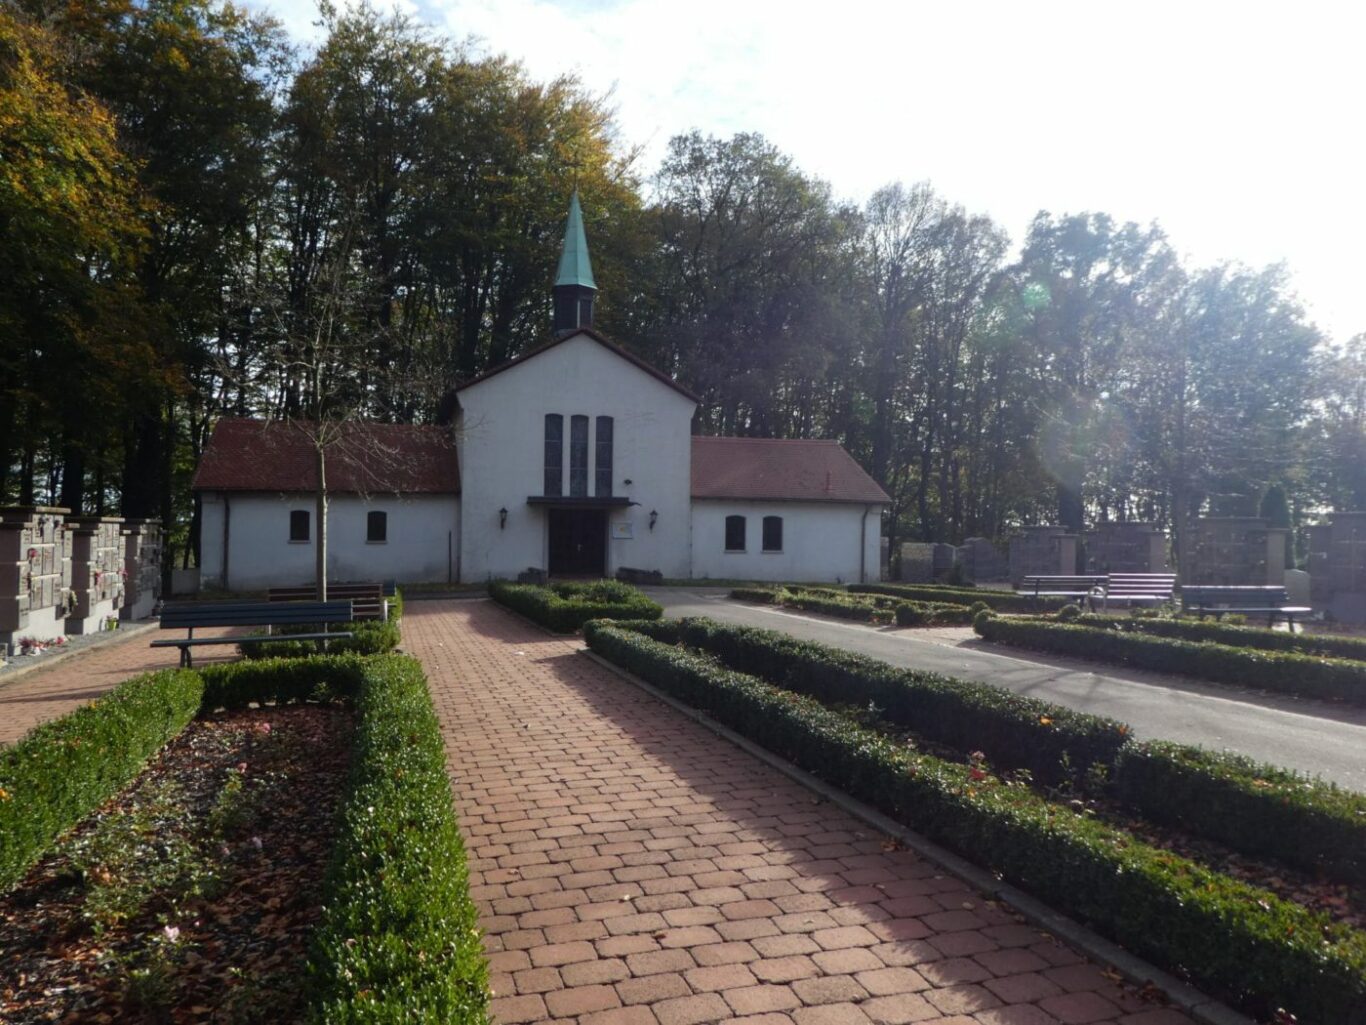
(403, 601), (1188, 1025)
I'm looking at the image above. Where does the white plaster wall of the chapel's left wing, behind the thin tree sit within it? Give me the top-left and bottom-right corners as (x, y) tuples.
(199, 491), (460, 590)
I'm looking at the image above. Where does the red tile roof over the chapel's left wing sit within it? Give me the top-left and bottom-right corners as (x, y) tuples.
(193, 418), (460, 495)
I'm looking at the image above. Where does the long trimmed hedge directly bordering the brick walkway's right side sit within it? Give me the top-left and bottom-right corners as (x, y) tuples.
(587, 623), (1366, 1025)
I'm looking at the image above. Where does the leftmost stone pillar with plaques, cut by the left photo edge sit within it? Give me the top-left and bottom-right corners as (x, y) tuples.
(0, 506), (71, 651)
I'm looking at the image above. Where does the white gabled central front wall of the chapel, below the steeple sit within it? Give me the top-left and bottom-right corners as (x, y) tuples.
(456, 335), (697, 581)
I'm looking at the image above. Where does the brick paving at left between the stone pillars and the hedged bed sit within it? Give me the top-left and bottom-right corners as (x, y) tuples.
(0, 627), (238, 743)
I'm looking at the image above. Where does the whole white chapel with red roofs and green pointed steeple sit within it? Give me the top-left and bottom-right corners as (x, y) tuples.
(194, 194), (889, 590)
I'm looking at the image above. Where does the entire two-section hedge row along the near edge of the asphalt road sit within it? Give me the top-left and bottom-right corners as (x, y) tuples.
(624, 619), (1366, 883)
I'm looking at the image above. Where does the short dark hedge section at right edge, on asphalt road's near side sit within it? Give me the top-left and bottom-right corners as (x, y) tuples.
(1115, 741), (1366, 884)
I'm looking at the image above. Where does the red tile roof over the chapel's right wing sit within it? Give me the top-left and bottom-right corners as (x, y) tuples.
(693, 437), (891, 504)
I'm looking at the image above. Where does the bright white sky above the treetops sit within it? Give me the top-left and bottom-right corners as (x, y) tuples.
(249, 0), (1366, 340)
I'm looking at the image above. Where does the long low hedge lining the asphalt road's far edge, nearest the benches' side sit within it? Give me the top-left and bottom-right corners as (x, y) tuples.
(973, 616), (1366, 705)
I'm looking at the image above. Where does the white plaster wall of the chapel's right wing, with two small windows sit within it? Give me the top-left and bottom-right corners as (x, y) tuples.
(691, 499), (882, 584)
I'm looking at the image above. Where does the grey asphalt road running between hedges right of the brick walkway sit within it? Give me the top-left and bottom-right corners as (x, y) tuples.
(646, 588), (1366, 791)
